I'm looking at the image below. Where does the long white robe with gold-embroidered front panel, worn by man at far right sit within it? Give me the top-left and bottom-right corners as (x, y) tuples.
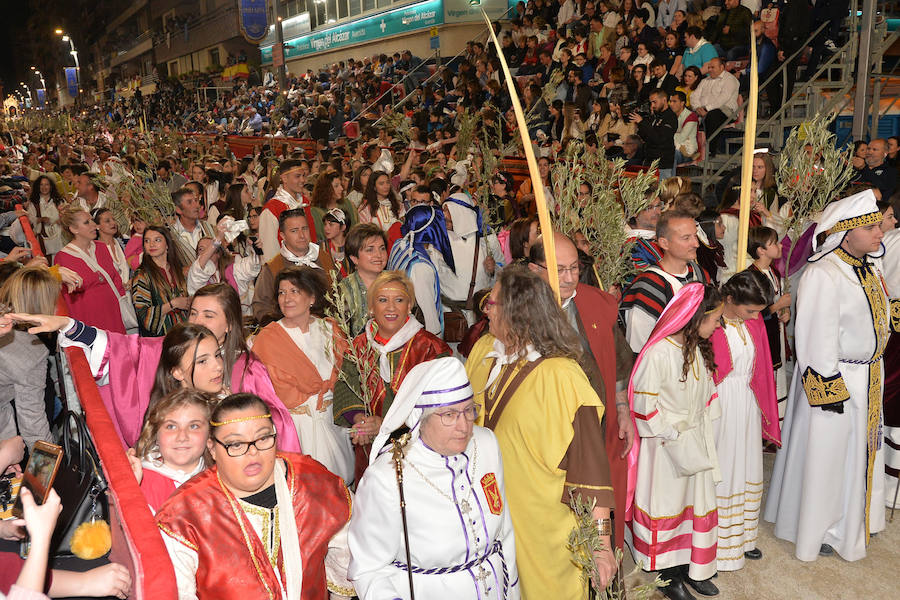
(764, 250), (888, 561)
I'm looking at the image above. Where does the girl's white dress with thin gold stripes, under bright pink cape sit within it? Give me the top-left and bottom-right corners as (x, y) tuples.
(713, 321), (763, 571)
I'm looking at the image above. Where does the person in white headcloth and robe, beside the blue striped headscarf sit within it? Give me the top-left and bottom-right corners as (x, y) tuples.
(437, 192), (505, 325)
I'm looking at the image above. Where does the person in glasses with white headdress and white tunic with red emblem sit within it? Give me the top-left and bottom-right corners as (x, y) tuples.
(349, 357), (520, 600)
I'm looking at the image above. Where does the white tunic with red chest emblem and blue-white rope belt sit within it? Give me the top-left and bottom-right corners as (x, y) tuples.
(349, 426), (519, 600)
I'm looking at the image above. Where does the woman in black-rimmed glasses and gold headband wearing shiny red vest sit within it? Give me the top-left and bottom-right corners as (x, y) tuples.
(156, 394), (354, 600)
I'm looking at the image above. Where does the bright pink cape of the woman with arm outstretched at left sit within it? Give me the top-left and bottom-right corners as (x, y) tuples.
(100, 332), (300, 453)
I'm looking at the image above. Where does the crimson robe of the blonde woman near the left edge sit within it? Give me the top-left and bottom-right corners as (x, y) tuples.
(53, 242), (125, 333)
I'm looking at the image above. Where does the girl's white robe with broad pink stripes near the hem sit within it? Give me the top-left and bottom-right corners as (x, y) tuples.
(625, 338), (721, 581)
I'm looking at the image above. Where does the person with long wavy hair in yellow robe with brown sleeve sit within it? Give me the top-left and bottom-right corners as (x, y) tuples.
(466, 265), (617, 598)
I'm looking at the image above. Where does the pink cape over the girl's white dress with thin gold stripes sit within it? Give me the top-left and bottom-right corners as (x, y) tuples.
(711, 315), (781, 446)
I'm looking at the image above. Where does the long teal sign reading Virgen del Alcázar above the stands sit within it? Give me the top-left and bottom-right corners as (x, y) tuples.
(260, 0), (444, 64)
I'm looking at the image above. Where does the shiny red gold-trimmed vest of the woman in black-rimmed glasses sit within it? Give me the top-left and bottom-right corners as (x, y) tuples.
(156, 452), (351, 600)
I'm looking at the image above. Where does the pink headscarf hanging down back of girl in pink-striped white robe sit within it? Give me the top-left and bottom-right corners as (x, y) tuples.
(625, 283), (704, 522)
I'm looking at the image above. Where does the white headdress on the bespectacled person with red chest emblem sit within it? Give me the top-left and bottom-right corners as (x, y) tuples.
(369, 356), (474, 464)
